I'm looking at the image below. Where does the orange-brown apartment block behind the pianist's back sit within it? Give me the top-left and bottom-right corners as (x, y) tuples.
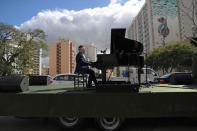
(49, 39), (75, 76)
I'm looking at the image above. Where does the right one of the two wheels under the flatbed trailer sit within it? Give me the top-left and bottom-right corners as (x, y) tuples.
(96, 117), (123, 131)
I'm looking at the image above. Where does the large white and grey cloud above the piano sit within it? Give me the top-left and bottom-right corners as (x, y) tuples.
(19, 0), (144, 65)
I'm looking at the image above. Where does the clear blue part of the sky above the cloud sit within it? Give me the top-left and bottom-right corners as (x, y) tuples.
(0, 0), (109, 25)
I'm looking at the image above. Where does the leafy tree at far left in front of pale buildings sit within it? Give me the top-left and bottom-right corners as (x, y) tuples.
(0, 23), (46, 76)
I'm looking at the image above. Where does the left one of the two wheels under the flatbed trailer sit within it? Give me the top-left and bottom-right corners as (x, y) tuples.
(58, 117), (81, 129)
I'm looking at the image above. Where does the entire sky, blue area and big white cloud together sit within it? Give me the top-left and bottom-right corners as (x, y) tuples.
(0, 0), (145, 65)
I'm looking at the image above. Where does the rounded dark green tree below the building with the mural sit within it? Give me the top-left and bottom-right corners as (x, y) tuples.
(146, 42), (195, 73)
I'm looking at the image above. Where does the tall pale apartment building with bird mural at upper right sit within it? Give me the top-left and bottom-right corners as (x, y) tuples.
(127, 0), (193, 53)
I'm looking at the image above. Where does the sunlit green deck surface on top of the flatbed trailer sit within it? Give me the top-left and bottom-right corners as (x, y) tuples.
(22, 84), (197, 94)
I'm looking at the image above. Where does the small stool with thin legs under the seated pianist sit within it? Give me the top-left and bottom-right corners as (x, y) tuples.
(74, 74), (88, 89)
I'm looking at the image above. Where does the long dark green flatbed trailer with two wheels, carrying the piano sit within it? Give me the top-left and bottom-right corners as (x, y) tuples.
(0, 85), (197, 131)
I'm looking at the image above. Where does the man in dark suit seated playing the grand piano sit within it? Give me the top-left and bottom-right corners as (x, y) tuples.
(75, 45), (97, 87)
